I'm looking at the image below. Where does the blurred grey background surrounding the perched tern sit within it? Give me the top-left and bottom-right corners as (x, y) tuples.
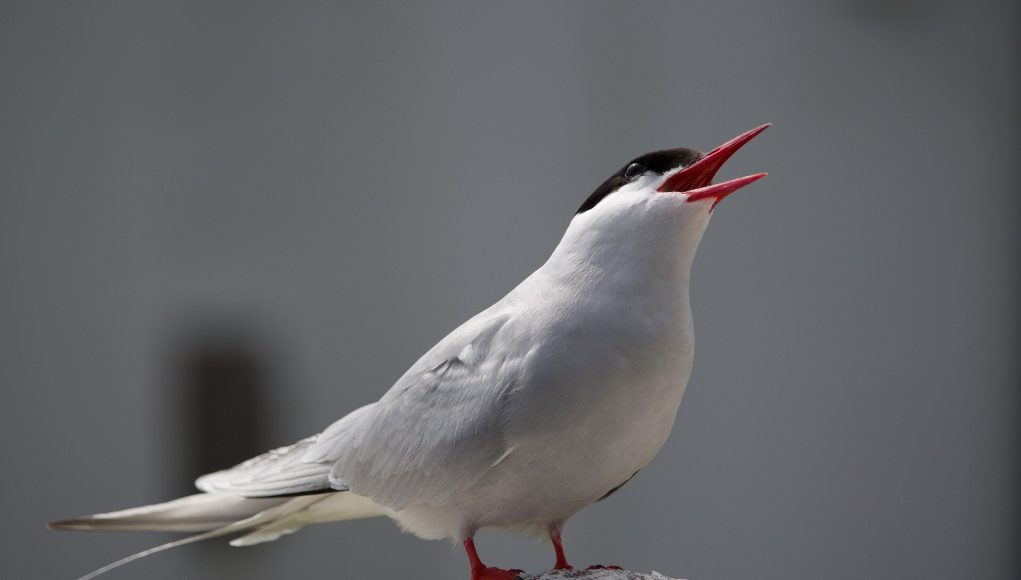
(0, 0), (1021, 580)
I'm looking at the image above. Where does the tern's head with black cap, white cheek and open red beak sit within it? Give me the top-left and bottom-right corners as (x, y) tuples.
(554, 125), (769, 283)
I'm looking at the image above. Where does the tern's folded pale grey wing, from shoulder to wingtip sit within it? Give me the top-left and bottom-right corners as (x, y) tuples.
(195, 310), (521, 509)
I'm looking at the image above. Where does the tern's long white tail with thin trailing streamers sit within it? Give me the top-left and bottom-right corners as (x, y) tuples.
(49, 491), (387, 580)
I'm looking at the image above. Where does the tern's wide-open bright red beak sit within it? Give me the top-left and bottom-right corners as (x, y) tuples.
(658, 123), (770, 210)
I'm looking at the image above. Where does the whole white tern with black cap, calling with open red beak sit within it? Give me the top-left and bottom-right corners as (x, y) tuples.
(50, 125), (769, 580)
